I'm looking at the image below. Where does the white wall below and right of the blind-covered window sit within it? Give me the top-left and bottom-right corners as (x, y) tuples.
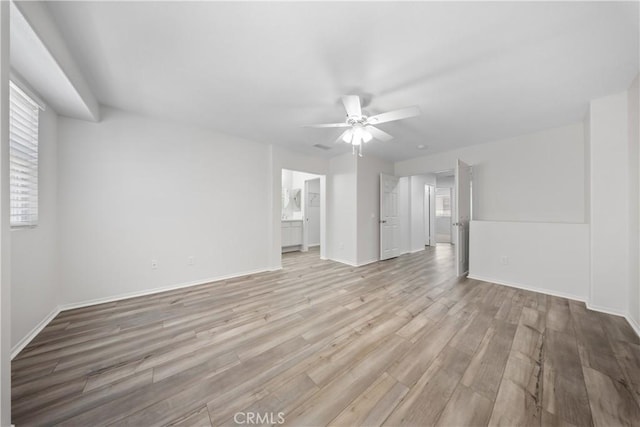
(11, 108), (62, 351)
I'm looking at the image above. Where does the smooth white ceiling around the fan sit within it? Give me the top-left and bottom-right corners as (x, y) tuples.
(48, 2), (639, 160)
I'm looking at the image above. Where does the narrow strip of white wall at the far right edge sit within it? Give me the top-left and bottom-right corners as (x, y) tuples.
(627, 74), (640, 331)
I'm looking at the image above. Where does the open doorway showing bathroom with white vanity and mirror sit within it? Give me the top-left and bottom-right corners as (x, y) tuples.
(280, 169), (324, 257)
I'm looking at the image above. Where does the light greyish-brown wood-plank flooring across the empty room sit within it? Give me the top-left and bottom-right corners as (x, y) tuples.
(12, 245), (640, 427)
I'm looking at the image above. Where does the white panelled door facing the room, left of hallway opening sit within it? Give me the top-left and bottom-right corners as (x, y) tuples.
(380, 174), (400, 259)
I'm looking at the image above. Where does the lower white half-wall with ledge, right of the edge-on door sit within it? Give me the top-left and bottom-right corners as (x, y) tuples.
(469, 221), (589, 301)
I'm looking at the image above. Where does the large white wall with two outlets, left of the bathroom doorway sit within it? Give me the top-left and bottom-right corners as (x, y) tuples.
(58, 108), (272, 303)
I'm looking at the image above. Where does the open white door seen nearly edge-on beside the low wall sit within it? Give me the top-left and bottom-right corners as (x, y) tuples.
(453, 159), (471, 276)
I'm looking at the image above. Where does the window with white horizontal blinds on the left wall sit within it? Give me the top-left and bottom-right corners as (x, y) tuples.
(9, 82), (39, 228)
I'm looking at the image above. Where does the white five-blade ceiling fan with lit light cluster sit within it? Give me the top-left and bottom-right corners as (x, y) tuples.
(307, 95), (420, 157)
